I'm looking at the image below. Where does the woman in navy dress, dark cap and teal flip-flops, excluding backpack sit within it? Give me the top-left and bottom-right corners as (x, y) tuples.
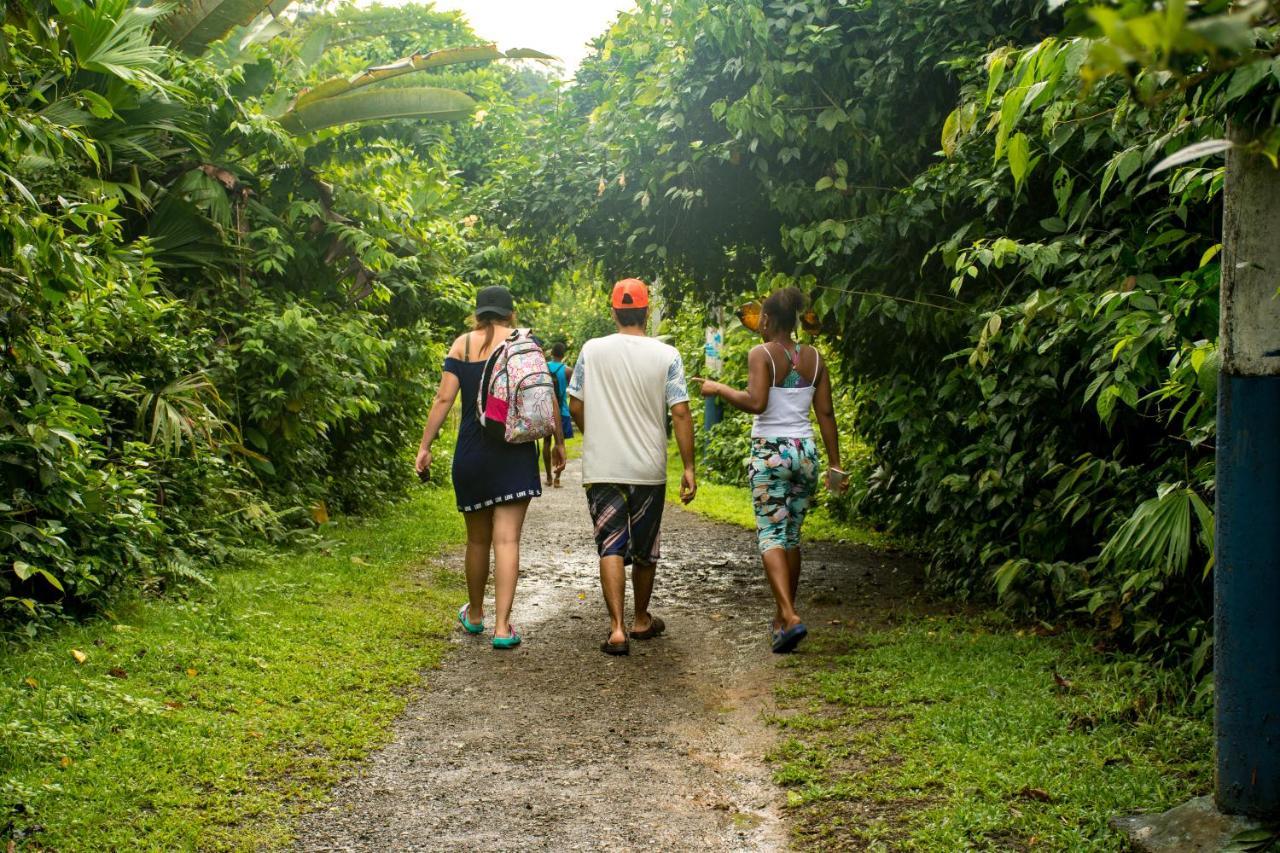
(416, 287), (564, 648)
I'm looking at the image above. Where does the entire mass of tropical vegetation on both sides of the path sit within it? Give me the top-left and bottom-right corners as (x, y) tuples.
(0, 0), (1280, 753)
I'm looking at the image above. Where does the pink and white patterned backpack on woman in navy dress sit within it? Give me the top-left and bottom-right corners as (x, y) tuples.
(476, 329), (559, 444)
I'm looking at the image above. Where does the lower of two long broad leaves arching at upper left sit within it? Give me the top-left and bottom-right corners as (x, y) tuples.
(280, 86), (476, 133)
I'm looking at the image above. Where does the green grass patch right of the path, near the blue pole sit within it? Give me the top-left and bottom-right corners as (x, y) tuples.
(772, 617), (1212, 852)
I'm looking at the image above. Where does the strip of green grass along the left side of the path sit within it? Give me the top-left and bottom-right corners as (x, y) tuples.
(0, 488), (465, 850)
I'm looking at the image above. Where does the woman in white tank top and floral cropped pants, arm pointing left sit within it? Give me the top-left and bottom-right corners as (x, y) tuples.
(695, 287), (847, 654)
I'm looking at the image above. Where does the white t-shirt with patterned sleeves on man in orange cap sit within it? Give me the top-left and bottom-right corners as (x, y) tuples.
(568, 334), (689, 485)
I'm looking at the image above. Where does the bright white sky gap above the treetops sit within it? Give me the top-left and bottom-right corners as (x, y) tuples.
(417, 0), (635, 76)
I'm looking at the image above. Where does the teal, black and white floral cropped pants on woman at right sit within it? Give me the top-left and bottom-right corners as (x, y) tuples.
(748, 438), (818, 553)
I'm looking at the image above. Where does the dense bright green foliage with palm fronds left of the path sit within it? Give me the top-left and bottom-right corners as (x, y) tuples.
(0, 0), (544, 631)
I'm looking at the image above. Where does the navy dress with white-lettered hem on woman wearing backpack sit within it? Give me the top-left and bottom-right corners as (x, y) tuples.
(444, 357), (543, 512)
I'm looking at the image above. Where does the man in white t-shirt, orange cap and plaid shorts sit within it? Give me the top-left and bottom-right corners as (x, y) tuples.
(568, 278), (698, 654)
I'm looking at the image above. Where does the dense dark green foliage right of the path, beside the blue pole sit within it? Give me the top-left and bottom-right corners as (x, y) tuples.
(494, 0), (1276, 672)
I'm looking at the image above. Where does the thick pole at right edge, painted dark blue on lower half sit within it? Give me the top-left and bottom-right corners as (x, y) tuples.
(1213, 136), (1280, 820)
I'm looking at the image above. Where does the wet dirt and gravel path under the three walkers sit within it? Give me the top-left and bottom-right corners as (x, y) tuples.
(297, 464), (915, 850)
